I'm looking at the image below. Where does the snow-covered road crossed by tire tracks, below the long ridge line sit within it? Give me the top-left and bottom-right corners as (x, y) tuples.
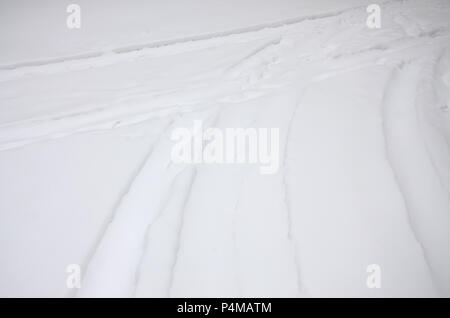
(0, 0), (450, 297)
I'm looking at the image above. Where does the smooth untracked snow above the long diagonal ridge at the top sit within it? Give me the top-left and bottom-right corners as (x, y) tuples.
(0, 0), (376, 67)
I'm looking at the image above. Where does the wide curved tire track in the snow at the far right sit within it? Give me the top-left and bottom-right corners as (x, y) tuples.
(382, 63), (450, 295)
